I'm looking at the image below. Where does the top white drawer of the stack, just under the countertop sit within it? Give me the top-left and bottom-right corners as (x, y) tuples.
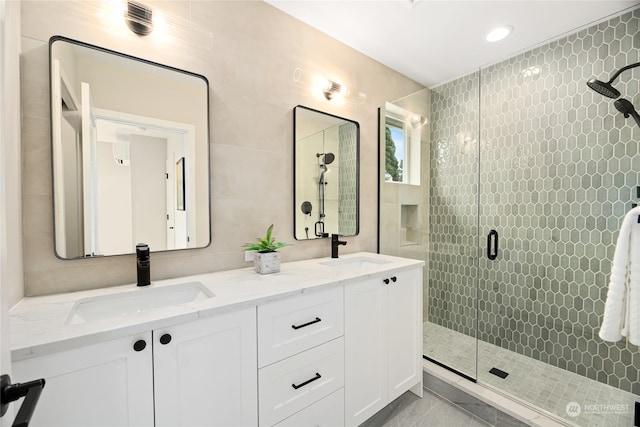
(258, 287), (344, 367)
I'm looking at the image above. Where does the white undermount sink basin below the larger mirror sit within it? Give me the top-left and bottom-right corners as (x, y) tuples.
(65, 282), (215, 325)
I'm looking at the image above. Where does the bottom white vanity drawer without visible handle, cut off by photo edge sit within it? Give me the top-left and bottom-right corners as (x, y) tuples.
(274, 388), (344, 427)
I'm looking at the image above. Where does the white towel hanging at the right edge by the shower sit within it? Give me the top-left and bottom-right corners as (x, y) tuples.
(599, 206), (640, 345)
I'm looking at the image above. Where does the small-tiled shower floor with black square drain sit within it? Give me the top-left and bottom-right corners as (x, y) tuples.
(423, 322), (640, 427)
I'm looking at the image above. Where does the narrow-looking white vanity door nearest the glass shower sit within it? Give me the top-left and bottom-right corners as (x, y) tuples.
(386, 268), (422, 402)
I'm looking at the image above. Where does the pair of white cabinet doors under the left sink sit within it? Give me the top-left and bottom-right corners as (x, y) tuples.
(13, 307), (257, 427)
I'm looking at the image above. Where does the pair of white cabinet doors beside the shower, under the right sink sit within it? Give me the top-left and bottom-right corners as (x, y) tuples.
(344, 267), (422, 426)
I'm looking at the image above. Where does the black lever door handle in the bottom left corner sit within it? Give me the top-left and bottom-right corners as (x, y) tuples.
(0, 375), (45, 427)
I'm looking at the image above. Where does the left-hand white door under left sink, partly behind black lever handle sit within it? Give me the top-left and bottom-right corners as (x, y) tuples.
(12, 332), (153, 427)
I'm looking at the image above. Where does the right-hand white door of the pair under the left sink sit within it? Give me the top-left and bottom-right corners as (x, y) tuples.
(153, 307), (258, 427)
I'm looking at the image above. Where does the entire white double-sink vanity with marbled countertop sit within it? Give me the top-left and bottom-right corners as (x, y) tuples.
(12, 253), (424, 427)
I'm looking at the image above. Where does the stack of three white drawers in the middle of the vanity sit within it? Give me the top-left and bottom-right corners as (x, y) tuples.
(258, 286), (344, 427)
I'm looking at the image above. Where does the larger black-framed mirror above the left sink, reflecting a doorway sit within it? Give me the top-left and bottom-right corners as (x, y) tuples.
(49, 36), (211, 259)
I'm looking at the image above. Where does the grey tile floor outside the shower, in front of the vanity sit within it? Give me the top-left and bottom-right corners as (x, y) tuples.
(360, 390), (489, 427)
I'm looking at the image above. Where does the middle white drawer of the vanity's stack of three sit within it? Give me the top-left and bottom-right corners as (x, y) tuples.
(258, 337), (344, 426)
